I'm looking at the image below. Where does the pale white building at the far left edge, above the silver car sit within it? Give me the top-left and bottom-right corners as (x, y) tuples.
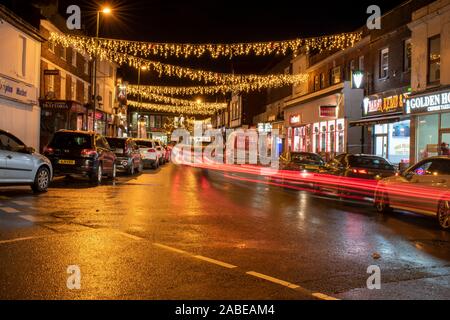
(0, 5), (44, 149)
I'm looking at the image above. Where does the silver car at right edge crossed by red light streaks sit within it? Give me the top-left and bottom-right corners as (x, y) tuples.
(374, 156), (450, 230)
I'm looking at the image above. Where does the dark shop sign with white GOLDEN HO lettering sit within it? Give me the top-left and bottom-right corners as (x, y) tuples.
(406, 91), (450, 114)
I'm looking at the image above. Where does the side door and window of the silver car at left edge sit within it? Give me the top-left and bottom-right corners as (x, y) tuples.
(0, 132), (34, 183)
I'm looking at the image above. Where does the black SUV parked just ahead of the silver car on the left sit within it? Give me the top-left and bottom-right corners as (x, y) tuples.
(44, 130), (117, 184)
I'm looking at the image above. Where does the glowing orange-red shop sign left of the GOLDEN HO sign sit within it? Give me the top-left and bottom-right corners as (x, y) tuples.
(363, 92), (409, 116)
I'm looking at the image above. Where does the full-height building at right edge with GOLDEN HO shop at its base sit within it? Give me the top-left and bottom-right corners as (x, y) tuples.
(406, 0), (450, 162)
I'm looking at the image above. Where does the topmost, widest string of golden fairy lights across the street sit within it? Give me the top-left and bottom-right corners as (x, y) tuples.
(50, 32), (362, 59)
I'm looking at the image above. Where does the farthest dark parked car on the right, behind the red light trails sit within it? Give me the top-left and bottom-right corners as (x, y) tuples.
(280, 152), (325, 172)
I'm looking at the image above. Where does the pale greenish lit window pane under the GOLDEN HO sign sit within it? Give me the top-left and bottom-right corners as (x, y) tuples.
(416, 114), (439, 161)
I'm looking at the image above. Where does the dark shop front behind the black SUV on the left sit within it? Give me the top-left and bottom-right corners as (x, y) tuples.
(40, 100), (87, 150)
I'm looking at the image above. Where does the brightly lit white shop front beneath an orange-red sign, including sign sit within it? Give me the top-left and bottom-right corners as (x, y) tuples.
(350, 88), (411, 167)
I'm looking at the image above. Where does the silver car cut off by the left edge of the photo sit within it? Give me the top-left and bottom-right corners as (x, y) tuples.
(0, 130), (53, 192)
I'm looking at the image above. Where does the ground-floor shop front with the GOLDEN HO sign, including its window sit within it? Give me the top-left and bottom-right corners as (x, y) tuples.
(406, 88), (450, 162)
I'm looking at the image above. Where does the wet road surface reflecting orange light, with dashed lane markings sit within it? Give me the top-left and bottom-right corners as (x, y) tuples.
(0, 164), (450, 299)
